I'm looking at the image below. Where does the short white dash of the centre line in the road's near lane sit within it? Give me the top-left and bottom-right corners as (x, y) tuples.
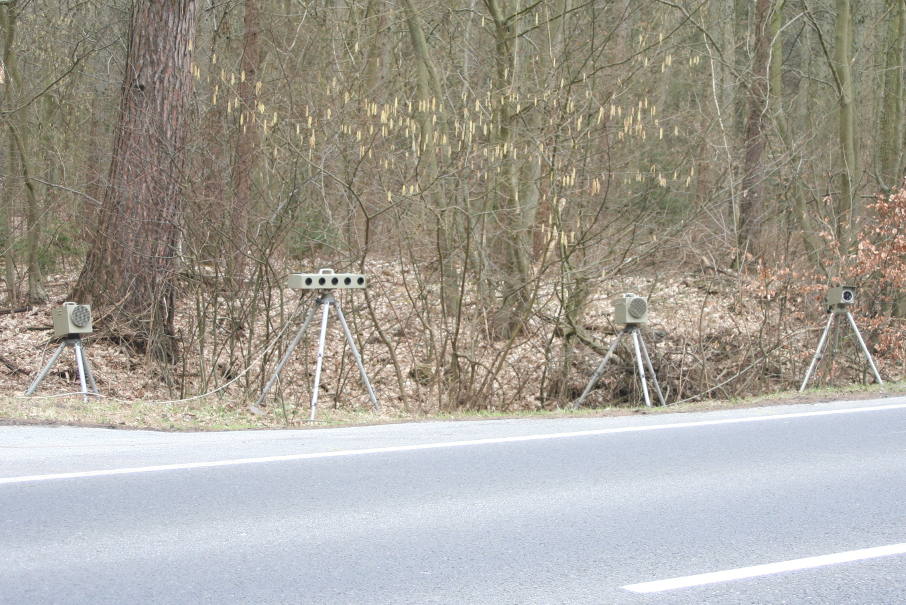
(623, 543), (906, 593)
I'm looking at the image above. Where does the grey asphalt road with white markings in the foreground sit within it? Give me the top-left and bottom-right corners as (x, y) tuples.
(0, 397), (906, 604)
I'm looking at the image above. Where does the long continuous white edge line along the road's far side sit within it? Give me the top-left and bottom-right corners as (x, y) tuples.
(0, 403), (906, 485)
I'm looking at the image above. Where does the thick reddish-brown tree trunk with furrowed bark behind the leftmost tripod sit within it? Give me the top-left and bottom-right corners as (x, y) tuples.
(72, 0), (195, 362)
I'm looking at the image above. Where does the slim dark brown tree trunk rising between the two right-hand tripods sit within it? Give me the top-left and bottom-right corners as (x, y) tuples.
(735, 0), (772, 267)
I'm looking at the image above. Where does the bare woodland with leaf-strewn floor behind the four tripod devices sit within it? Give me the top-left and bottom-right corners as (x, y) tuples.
(0, 0), (906, 420)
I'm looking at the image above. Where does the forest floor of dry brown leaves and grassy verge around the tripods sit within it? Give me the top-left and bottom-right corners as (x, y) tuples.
(0, 263), (906, 431)
